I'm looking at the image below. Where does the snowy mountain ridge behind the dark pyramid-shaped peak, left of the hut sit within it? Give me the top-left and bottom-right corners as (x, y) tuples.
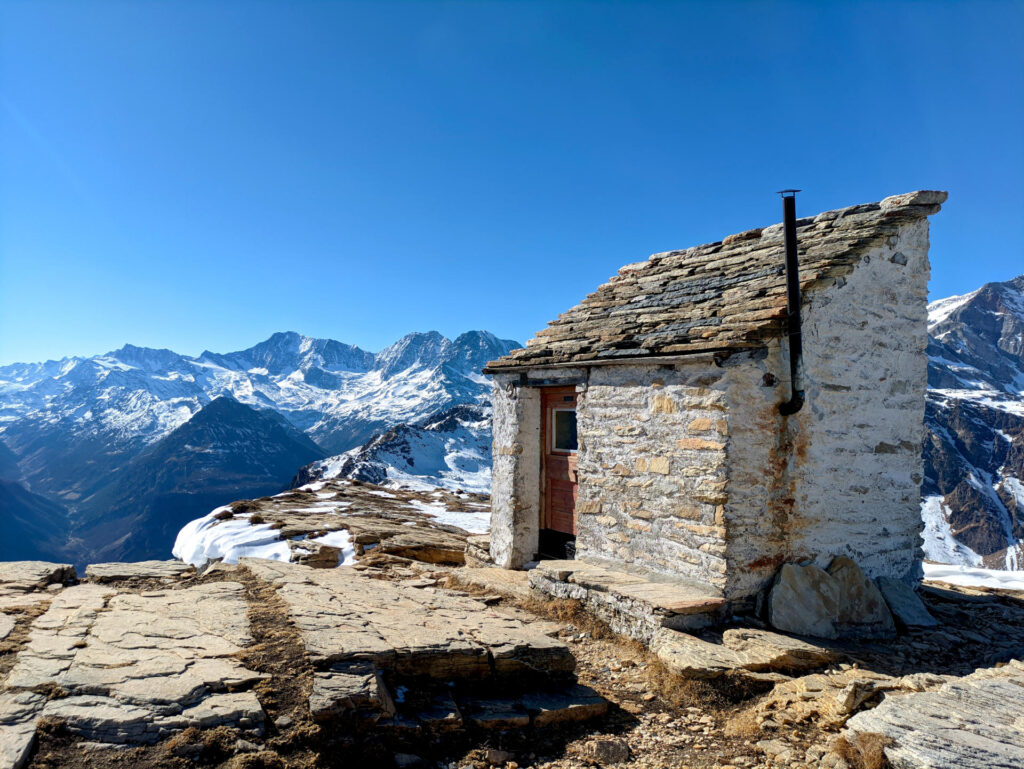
(0, 331), (517, 460)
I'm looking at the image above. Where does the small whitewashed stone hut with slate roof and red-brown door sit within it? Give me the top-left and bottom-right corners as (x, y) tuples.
(484, 190), (946, 606)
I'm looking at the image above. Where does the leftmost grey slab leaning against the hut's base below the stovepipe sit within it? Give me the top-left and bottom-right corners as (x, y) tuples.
(768, 563), (840, 638)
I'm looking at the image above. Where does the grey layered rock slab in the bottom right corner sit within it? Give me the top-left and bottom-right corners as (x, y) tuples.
(847, 660), (1024, 769)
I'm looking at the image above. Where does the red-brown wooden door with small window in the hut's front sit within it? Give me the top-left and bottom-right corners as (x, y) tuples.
(542, 387), (578, 536)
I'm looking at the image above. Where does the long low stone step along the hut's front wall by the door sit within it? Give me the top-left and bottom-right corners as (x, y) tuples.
(529, 560), (725, 644)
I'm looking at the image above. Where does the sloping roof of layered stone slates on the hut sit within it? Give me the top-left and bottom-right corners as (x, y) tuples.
(484, 190), (946, 373)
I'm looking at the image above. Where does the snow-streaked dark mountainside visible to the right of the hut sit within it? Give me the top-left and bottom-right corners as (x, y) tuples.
(922, 275), (1024, 569)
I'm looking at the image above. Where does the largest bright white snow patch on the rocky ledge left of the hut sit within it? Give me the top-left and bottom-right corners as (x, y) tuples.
(171, 507), (292, 568)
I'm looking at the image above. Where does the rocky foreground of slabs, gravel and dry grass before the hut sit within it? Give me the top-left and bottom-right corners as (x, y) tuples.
(0, 499), (1024, 769)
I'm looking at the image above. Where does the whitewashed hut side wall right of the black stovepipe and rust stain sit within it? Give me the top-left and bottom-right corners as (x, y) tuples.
(778, 219), (930, 578)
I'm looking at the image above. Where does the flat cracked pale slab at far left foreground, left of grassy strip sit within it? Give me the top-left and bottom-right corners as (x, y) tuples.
(0, 582), (263, 769)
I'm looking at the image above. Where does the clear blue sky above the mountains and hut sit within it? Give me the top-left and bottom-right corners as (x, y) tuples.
(0, 0), (1024, 361)
